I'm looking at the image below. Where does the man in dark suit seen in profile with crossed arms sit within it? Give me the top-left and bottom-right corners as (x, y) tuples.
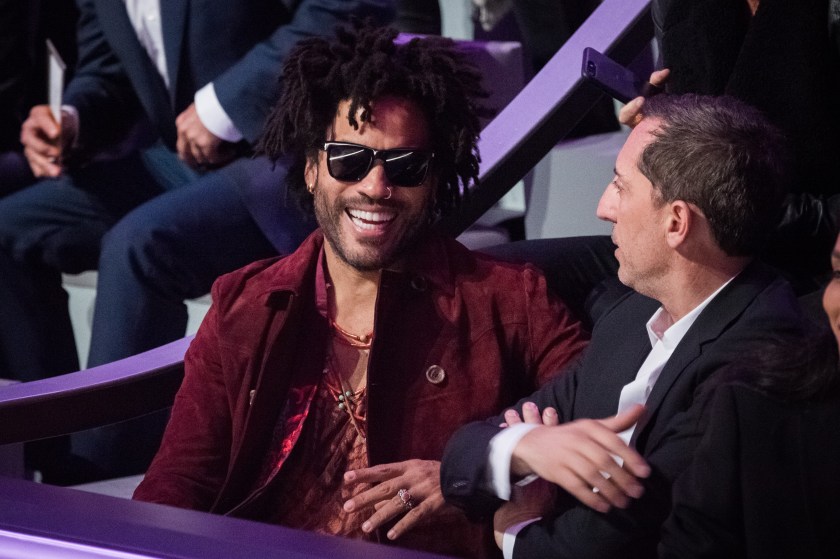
(441, 96), (803, 557)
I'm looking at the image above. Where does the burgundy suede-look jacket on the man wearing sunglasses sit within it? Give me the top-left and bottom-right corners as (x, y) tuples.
(134, 231), (586, 556)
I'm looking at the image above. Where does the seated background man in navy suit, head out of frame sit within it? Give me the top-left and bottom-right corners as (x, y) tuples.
(0, 0), (393, 482)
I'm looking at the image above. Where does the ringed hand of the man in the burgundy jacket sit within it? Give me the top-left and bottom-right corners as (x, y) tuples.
(344, 460), (455, 540)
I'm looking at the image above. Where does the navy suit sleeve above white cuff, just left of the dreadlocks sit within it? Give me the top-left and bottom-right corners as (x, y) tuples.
(213, 0), (394, 144)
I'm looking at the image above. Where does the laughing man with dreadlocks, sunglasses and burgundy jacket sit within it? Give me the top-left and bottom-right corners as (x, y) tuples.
(134, 25), (585, 556)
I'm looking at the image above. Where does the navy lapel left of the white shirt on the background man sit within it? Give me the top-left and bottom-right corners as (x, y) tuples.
(95, 0), (176, 146)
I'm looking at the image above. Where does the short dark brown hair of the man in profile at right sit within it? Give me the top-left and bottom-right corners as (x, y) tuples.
(638, 94), (789, 256)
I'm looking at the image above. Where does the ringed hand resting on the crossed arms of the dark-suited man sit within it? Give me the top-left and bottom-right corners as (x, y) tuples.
(506, 406), (650, 512)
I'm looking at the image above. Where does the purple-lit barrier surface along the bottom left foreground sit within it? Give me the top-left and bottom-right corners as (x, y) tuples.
(0, 478), (452, 559)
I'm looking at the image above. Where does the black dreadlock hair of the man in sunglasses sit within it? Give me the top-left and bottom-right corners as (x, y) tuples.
(257, 20), (488, 214)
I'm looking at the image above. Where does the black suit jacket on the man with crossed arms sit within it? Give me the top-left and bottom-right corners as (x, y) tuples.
(441, 263), (805, 558)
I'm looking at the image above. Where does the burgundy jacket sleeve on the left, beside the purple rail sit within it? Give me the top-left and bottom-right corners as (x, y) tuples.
(134, 282), (232, 511)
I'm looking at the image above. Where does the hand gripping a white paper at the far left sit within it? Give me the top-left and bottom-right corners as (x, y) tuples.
(20, 105), (67, 177)
